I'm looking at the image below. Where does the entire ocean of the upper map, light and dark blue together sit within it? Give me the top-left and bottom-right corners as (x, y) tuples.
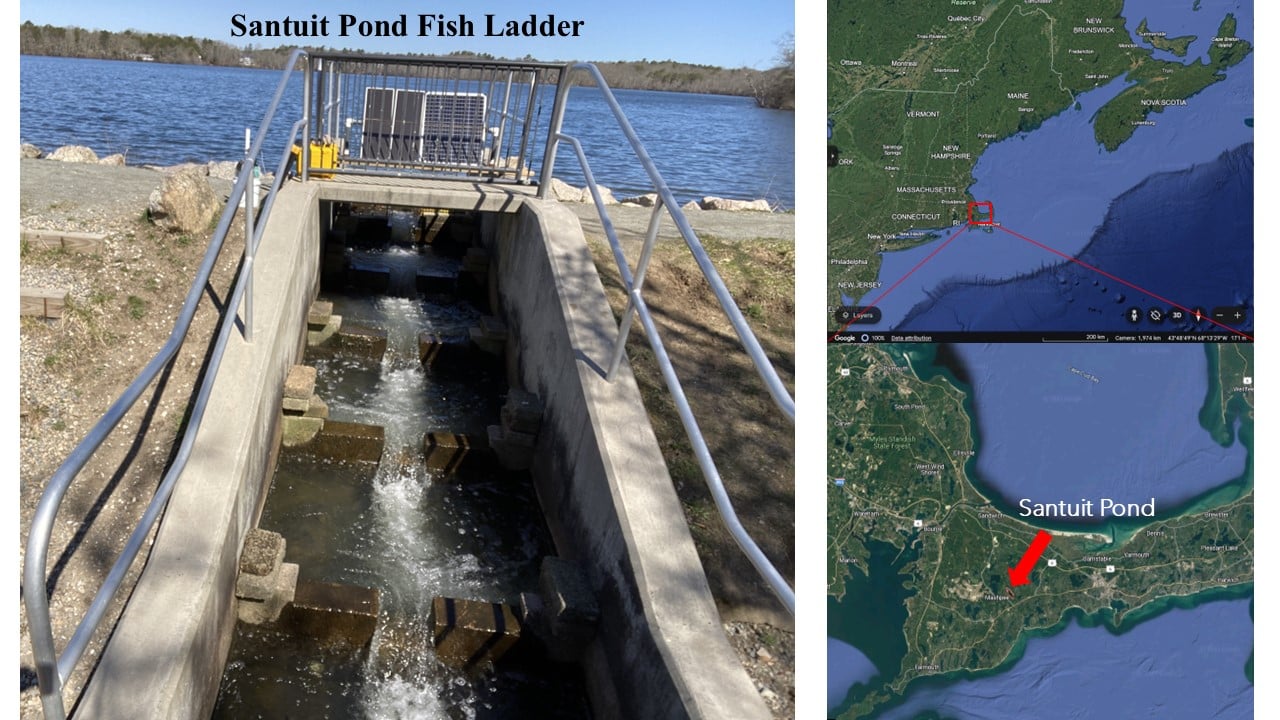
(849, 0), (1253, 331)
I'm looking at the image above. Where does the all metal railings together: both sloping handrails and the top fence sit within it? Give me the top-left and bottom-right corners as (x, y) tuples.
(22, 50), (795, 720)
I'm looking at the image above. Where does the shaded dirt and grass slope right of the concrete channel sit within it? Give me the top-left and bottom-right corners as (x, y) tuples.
(584, 204), (795, 717)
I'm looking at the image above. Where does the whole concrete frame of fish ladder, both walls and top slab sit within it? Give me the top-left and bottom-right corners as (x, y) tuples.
(74, 179), (769, 720)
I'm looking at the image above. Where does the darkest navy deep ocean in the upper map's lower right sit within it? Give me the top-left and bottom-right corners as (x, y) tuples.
(899, 145), (1253, 333)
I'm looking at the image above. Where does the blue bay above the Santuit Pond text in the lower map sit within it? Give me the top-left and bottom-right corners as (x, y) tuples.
(951, 343), (1248, 512)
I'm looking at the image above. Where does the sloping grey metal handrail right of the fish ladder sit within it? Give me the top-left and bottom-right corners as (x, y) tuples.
(538, 63), (795, 615)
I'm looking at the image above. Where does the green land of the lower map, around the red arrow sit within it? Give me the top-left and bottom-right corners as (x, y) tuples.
(827, 345), (1253, 717)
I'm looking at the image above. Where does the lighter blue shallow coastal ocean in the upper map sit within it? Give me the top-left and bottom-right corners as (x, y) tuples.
(856, 3), (1253, 329)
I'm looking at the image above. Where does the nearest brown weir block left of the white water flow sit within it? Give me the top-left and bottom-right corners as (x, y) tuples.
(280, 580), (380, 647)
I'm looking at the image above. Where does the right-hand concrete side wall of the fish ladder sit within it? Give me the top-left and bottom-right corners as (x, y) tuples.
(490, 200), (769, 720)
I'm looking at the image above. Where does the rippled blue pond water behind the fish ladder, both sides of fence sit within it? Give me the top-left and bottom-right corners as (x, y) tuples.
(20, 55), (795, 209)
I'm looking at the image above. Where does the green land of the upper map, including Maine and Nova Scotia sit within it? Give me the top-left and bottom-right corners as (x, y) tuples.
(827, 0), (1252, 316)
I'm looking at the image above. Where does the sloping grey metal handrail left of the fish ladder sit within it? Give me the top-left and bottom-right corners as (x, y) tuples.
(22, 49), (306, 720)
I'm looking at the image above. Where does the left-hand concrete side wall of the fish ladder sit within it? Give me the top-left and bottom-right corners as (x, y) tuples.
(74, 183), (320, 720)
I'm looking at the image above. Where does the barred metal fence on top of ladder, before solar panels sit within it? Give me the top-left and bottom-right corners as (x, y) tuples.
(302, 53), (564, 184)
